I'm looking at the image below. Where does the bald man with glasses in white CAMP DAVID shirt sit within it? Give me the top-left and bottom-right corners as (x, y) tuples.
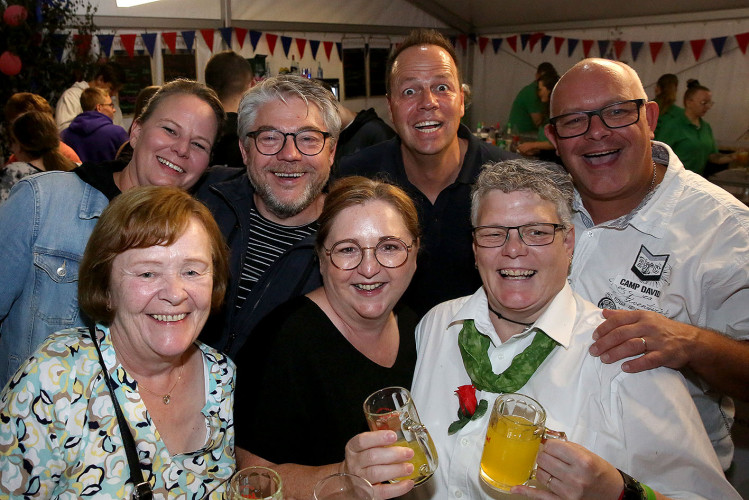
(546, 59), (749, 472)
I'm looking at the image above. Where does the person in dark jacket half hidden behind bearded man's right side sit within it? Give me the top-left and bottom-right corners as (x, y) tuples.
(335, 104), (395, 165)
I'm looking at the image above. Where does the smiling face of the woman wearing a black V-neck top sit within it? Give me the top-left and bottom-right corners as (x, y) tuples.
(320, 200), (418, 325)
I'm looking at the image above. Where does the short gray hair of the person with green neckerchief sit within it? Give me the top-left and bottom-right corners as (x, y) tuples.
(471, 158), (574, 228)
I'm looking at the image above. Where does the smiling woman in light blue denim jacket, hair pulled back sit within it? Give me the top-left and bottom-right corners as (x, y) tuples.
(0, 80), (224, 385)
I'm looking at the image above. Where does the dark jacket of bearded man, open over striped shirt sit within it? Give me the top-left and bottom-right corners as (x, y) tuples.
(195, 166), (322, 358)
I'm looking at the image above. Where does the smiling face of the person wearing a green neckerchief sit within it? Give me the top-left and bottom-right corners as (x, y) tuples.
(473, 190), (575, 323)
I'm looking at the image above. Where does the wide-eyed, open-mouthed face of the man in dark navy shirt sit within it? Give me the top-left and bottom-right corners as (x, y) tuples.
(388, 45), (465, 159)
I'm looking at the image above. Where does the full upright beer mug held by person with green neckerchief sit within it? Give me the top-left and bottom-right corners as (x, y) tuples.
(481, 394), (567, 493)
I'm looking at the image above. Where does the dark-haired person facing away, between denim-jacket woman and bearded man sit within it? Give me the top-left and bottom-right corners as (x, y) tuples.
(205, 50), (255, 168)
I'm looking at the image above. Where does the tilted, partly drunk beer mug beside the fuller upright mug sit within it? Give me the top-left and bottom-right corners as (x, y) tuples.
(364, 387), (437, 485)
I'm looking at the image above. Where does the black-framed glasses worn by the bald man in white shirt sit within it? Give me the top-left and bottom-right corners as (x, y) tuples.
(549, 99), (647, 139)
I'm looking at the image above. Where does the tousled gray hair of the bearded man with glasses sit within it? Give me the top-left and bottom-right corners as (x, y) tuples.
(237, 75), (341, 143)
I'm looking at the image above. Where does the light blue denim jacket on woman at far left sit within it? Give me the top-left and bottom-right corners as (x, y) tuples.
(0, 172), (109, 387)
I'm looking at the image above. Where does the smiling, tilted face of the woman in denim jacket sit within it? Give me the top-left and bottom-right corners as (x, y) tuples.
(117, 94), (218, 191)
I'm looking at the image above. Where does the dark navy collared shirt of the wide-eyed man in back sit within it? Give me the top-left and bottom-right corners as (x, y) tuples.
(338, 125), (518, 316)
